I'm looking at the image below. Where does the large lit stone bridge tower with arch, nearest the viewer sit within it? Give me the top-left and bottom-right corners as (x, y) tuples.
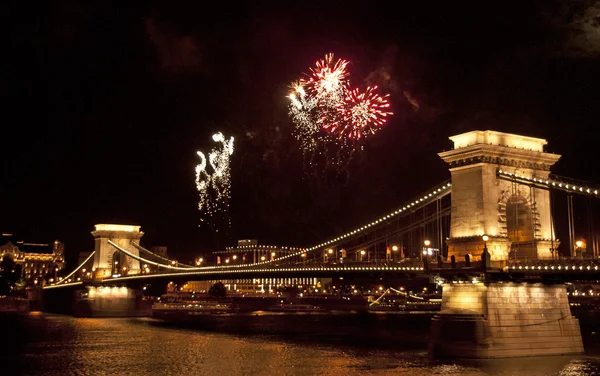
(438, 130), (560, 261)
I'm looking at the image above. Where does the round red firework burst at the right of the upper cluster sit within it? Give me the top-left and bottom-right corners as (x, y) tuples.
(323, 86), (392, 140)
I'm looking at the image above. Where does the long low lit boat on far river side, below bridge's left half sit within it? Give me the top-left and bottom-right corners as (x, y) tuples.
(152, 301), (238, 318)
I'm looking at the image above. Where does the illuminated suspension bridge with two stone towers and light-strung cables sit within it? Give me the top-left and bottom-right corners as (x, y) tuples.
(45, 131), (600, 357)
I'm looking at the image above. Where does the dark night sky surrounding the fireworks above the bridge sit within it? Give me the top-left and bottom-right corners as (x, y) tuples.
(0, 0), (600, 264)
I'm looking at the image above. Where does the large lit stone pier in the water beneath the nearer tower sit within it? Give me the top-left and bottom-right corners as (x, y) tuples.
(429, 283), (583, 358)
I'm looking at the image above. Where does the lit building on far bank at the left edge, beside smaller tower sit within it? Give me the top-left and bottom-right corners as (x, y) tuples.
(0, 234), (65, 282)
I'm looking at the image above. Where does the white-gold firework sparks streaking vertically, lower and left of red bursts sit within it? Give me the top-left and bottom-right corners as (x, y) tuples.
(195, 132), (233, 226)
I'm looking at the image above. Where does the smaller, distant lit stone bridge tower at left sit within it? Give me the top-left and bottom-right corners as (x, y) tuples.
(92, 224), (144, 278)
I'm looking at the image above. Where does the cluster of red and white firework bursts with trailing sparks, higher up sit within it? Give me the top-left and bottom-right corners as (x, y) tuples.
(288, 53), (392, 184)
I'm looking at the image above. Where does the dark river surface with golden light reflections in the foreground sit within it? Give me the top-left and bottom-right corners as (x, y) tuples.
(0, 312), (600, 376)
